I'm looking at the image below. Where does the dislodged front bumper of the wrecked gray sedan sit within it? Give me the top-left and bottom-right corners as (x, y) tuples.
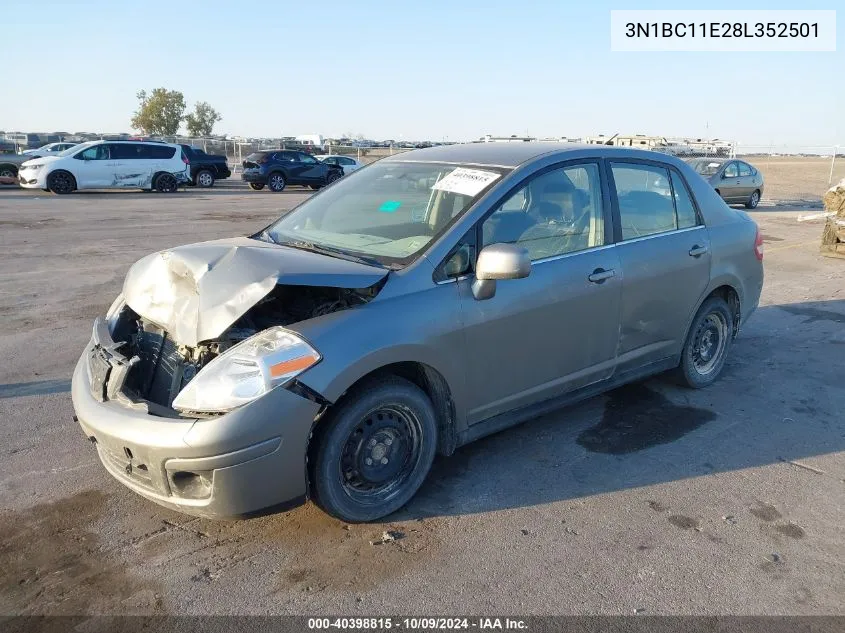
(71, 319), (321, 518)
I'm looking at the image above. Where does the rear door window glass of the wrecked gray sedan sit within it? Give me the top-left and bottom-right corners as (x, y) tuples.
(611, 163), (678, 240)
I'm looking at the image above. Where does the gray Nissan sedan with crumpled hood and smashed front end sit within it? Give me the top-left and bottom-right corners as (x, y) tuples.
(72, 143), (763, 521)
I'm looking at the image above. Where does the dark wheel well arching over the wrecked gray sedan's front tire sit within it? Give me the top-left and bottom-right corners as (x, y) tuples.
(316, 361), (457, 455)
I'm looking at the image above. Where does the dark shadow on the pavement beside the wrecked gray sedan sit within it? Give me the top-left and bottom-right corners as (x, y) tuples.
(392, 300), (845, 520)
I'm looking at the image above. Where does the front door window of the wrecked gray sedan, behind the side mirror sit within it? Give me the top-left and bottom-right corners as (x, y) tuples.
(481, 163), (604, 261)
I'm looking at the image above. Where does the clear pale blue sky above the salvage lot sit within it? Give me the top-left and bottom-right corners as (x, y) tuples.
(0, 0), (845, 146)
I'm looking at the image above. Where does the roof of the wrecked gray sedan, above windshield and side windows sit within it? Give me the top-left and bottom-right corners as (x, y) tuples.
(382, 141), (680, 167)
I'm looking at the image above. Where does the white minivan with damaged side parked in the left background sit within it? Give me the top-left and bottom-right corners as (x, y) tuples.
(18, 141), (191, 194)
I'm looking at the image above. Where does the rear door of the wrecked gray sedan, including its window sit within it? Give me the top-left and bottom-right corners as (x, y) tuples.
(608, 161), (710, 373)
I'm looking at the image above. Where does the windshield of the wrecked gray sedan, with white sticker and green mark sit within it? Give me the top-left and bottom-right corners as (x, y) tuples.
(260, 161), (507, 267)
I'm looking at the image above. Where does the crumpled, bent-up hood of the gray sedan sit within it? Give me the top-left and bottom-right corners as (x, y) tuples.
(123, 237), (388, 347)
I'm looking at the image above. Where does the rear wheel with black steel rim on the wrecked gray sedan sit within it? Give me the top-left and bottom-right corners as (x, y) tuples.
(675, 297), (734, 389)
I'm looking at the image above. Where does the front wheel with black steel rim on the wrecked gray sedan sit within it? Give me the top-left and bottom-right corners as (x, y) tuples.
(309, 377), (437, 523)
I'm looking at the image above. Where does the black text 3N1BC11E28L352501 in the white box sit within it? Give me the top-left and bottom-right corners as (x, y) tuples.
(625, 22), (819, 38)
